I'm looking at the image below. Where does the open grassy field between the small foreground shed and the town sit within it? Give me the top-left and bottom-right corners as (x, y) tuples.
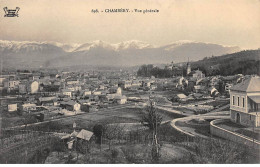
(22, 108), (181, 133)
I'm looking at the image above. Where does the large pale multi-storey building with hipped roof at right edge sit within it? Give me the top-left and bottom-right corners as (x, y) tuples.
(230, 77), (260, 127)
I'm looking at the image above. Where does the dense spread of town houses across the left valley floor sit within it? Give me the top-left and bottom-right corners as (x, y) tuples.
(0, 69), (164, 116)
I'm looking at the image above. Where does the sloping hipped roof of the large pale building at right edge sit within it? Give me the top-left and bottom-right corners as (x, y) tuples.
(230, 77), (260, 92)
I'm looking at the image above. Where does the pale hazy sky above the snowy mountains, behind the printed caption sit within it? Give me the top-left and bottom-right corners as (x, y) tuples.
(0, 0), (260, 49)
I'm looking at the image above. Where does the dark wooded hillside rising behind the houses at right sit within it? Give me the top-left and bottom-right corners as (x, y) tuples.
(191, 49), (260, 76)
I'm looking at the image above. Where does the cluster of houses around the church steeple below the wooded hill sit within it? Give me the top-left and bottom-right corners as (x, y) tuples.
(153, 59), (258, 102)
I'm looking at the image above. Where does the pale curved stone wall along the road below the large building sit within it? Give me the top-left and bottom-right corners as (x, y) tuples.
(210, 119), (260, 149)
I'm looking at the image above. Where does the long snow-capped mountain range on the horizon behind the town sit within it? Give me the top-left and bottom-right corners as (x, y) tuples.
(0, 40), (241, 68)
